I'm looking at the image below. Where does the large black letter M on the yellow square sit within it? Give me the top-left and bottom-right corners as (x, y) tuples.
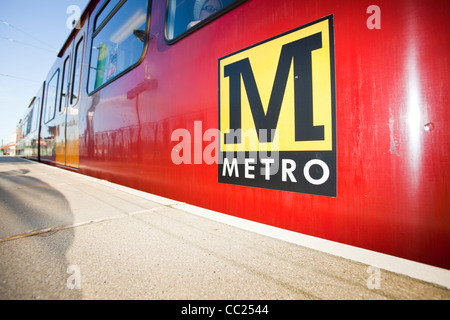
(224, 33), (324, 144)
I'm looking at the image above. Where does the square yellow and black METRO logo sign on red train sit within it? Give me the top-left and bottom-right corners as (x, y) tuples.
(219, 16), (336, 196)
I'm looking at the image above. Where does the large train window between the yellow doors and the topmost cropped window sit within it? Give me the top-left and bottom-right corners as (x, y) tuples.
(88, 0), (149, 93)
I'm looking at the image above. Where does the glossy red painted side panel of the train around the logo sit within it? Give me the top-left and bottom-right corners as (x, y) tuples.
(17, 0), (450, 269)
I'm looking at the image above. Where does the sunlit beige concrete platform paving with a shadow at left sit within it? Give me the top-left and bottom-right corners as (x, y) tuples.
(0, 157), (450, 300)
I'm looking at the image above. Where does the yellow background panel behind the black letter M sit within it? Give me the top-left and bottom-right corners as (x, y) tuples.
(220, 20), (333, 151)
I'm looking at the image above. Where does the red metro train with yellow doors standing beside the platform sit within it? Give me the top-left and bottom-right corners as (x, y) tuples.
(17, 0), (450, 269)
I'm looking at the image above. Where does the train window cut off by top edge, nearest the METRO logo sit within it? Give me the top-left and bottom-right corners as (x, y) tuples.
(166, 0), (242, 41)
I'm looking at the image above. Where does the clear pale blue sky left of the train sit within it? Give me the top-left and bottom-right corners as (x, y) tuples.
(0, 0), (89, 144)
